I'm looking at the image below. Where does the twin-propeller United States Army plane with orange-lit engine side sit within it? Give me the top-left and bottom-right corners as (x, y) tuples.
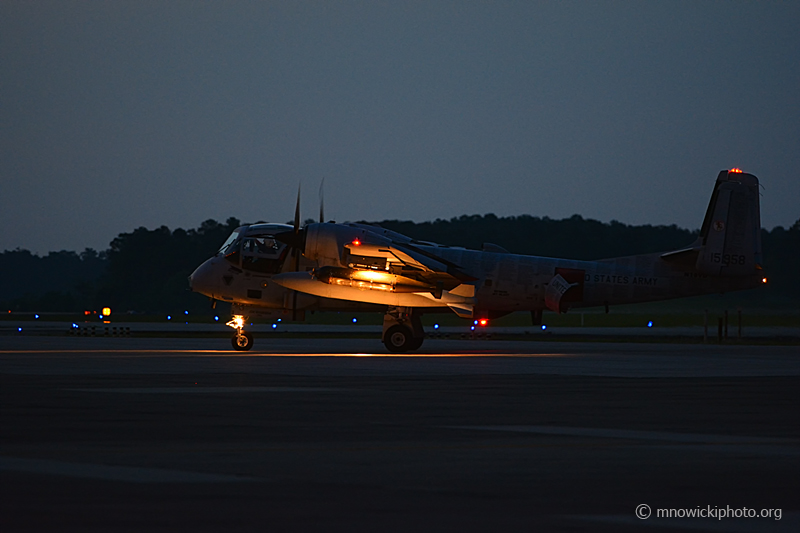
(189, 169), (766, 352)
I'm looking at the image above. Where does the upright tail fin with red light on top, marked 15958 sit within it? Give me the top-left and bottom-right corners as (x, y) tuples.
(696, 169), (761, 276)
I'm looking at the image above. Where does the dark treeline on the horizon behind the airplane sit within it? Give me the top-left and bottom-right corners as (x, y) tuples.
(0, 214), (800, 313)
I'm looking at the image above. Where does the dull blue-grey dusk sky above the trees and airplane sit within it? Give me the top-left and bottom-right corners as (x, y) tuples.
(0, 1), (800, 253)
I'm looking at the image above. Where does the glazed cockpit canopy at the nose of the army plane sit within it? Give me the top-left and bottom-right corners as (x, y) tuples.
(217, 224), (292, 274)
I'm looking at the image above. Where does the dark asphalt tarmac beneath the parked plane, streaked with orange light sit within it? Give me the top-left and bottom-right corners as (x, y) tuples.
(0, 336), (800, 533)
